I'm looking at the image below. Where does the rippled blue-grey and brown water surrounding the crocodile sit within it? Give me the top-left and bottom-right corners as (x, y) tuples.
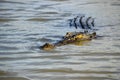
(0, 0), (120, 80)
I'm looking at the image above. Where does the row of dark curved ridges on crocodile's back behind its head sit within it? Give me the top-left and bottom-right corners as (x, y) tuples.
(69, 15), (95, 30)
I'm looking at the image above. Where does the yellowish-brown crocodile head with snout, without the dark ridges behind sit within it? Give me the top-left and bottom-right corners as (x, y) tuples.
(40, 32), (96, 50)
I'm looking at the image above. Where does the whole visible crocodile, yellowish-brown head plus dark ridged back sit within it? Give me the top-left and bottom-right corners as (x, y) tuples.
(39, 16), (97, 50)
